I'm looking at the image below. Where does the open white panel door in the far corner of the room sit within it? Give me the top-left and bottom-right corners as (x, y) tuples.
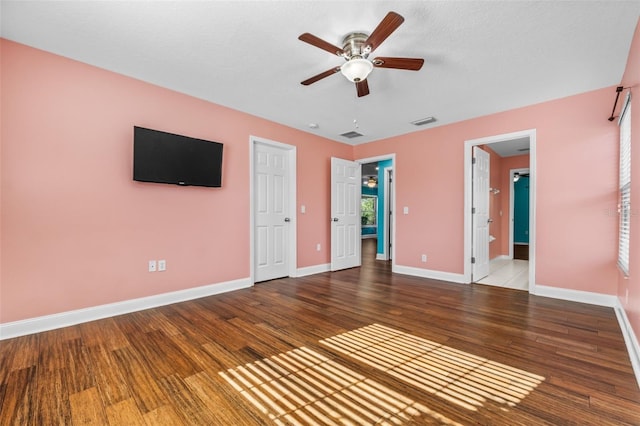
(331, 158), (362, 271)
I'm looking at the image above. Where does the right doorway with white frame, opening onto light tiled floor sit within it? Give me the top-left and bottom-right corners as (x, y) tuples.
(465, 129), (535, 291)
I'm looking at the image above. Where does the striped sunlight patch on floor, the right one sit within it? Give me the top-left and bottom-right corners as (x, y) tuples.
(320, 324), (544, 411)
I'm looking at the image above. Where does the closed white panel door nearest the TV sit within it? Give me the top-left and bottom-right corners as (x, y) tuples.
(253, 143), (294, 282)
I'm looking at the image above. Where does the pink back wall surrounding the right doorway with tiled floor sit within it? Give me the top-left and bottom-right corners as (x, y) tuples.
(354, 88), (620, 294)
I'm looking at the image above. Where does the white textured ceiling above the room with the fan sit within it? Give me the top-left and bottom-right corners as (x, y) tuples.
(0, 0), (640, 144)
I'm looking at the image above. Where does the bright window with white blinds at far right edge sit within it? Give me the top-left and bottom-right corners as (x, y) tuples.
(618, 92), (631, 276)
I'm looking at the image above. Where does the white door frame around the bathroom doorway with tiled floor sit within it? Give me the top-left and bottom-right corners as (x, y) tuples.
(463, 129), (537, 293)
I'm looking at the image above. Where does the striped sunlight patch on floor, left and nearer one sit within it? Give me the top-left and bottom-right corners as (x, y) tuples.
(219, 347), (458, 425)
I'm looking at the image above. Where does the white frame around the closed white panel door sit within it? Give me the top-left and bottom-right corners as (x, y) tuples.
(249, 135), (298, 285)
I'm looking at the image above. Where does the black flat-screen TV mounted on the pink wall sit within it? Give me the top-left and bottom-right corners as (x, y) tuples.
(133, 126), (223, 188)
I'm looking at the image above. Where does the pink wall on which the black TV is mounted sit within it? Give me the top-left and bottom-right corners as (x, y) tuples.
(0, 40), (353, 323)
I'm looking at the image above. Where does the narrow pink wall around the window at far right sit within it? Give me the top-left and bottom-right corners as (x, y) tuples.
(609, 20), (640, 352)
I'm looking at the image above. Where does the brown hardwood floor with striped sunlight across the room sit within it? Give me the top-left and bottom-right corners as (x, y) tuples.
(0, 240), (640, 425)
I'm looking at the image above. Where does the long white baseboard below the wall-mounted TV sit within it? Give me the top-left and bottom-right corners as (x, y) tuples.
(0, 278), (252, 340)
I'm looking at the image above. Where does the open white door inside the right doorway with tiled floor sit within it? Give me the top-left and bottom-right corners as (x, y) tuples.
(471, 146), (490, 281)
